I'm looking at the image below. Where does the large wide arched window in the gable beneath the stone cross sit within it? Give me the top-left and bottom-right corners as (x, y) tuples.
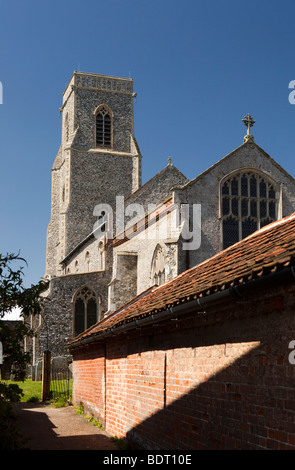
(220, 169), (279, 249)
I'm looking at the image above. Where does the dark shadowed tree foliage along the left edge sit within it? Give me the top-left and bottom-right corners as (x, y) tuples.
(0, 253), (47, 450)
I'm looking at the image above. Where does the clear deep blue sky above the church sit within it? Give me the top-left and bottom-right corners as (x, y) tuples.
(0, 0), (295, 285)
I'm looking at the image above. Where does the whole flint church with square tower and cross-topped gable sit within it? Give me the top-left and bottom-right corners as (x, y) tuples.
(32, 72), (295, 362)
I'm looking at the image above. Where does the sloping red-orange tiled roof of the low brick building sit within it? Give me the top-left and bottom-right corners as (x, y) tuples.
(69, 212), (295, 345)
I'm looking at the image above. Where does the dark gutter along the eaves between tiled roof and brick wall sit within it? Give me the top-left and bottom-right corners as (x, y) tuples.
(72, 267), (295, 348)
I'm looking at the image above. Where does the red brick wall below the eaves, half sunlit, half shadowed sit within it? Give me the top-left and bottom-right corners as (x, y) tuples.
(72, 287), (295, 450)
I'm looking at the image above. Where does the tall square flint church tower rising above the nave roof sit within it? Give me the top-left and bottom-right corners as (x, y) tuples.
(46, 72), (141, 279)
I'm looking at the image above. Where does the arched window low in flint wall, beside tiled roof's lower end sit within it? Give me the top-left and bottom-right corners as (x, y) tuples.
(74, 286), (99, 336)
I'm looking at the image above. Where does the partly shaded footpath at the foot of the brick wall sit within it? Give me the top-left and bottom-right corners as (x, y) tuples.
(14, 403), (118, 451)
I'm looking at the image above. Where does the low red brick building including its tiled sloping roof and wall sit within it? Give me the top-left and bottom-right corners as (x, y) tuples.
(69, 214), (295, 450)
